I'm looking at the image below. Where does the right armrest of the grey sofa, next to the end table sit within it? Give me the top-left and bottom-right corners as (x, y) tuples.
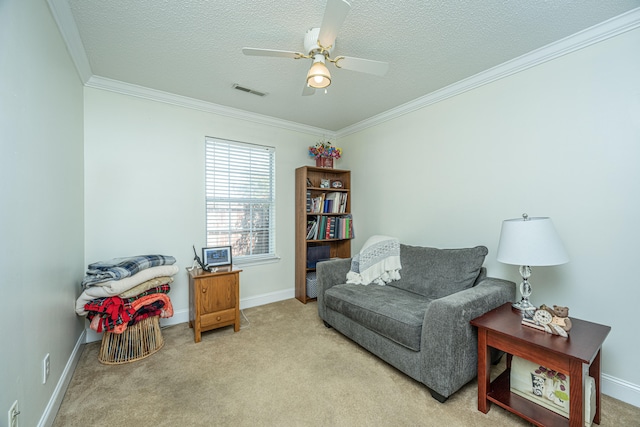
(420, 277), (516, 397)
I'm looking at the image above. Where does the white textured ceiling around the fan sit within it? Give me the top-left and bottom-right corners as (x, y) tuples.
(62, 0), (640, 131)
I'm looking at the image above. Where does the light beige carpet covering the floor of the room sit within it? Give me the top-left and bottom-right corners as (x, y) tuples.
(54, 300), (640, 427)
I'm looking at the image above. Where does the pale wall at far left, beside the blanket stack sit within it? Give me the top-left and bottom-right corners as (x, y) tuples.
(0, 0), (84, 426)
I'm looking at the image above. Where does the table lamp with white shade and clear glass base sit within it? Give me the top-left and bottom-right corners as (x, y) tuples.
(496, 213), (569, 312)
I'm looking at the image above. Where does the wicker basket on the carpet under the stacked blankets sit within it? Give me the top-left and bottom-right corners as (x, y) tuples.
(98, 316), (164, 365)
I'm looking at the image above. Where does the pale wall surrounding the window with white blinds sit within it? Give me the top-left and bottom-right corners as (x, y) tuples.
(85, 88), (317, 322)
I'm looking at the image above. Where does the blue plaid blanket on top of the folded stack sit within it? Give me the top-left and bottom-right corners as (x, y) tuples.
(82, 255), (176, 289)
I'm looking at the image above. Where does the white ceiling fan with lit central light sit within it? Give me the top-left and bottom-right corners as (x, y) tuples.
(242, 0), (389, 95)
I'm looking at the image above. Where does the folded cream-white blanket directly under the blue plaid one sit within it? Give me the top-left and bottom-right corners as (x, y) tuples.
(76, 264), (179, 316)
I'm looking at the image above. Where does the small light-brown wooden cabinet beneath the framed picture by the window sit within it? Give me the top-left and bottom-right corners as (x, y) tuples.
(188, 266), (242, 342)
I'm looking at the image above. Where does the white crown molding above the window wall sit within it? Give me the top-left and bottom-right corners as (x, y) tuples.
(85, 76), (335, 136)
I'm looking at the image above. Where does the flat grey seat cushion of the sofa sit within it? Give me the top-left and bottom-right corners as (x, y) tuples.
(324, 284), (431, 351)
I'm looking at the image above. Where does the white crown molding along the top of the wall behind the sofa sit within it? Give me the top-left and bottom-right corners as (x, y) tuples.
(336, 7), (640, 138)
